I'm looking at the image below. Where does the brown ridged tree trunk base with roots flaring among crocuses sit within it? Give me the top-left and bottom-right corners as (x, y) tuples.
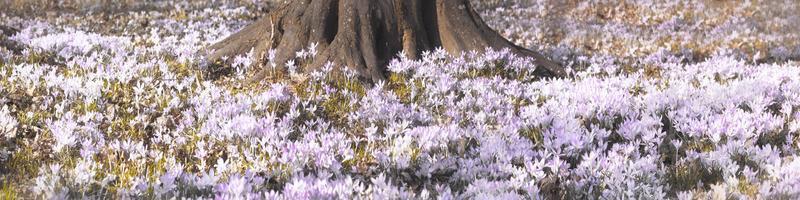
(207, 0), (566, 81)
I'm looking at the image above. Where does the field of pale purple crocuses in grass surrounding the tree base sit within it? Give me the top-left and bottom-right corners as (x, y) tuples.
(0, 0), (800, 199)
